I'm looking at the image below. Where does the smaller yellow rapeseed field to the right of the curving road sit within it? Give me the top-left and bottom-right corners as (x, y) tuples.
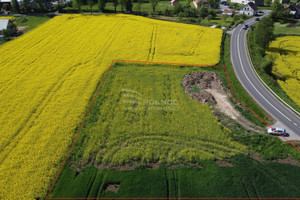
(267, 36), (300, 106)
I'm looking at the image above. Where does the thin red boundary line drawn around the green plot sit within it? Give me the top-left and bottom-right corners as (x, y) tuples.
(45, 60), (300, 199)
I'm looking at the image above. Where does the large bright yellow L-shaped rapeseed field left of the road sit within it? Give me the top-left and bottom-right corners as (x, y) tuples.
(0, 14), (222, 200)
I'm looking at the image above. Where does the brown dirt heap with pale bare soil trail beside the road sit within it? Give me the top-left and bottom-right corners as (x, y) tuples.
(182, 71), (265, 133)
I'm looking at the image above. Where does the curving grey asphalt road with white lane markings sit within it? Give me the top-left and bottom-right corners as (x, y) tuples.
(230, 14), (300, 140)
